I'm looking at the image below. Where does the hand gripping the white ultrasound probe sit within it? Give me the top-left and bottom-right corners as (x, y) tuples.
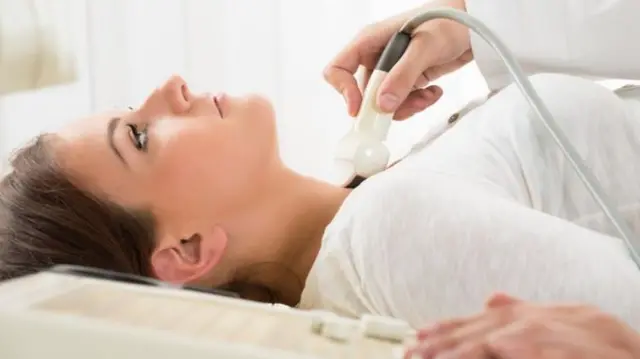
(324, 0), (473, 120)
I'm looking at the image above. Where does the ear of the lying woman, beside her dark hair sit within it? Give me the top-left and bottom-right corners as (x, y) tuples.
(151, 226), (228, 284)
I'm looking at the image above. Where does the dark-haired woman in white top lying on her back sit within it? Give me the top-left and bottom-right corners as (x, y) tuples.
(0, 75), (640, 329)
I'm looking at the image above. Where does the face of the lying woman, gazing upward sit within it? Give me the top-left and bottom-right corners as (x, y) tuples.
(55, 77), (280, 282)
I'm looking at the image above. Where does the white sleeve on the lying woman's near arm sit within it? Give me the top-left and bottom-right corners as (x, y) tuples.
(351, 175), (640, 329)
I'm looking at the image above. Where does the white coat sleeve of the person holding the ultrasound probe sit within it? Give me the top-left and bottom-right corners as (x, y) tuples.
(466, 0), (640, 89)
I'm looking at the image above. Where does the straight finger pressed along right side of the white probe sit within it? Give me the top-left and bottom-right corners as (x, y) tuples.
(377, 32), (440, 112)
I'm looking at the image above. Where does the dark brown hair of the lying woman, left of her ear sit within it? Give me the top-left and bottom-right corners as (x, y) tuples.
(0, 135), (154, 280)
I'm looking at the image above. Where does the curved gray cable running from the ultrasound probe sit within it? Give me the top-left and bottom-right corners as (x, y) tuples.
(400, 8), (640, 267)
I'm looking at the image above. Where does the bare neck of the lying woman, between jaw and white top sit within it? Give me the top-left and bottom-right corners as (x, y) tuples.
(220, 169), (350, 305)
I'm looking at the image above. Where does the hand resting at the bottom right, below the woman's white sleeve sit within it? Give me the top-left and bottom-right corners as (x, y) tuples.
(406, 294), (640, 359)
